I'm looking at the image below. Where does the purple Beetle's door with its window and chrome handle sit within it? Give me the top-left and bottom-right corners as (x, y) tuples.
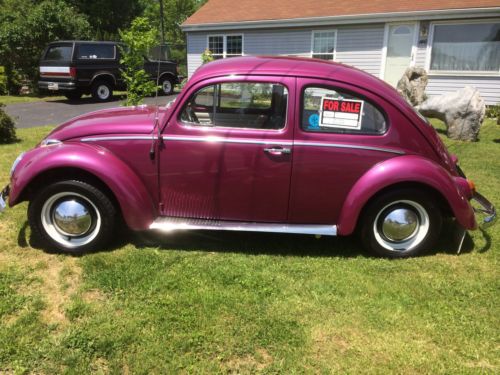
(159, 76), (295, 222)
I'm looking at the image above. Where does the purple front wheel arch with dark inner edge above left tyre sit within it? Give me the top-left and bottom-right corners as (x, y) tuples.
(9, 144), (157, 230)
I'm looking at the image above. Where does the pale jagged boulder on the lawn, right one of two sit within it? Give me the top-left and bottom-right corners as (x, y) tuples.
(416, 86), (486, 141)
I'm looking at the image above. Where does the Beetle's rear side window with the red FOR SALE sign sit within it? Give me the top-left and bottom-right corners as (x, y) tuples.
(302, 87), (387, 134)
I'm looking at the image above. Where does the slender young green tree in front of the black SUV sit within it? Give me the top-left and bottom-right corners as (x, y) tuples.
(119, 17), (158, 105)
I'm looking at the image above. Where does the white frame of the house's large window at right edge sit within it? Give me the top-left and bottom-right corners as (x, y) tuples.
(425, 18), (500, 77)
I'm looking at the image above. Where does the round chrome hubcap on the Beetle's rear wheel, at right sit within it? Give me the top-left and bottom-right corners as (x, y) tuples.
(382, 208), (419, 242)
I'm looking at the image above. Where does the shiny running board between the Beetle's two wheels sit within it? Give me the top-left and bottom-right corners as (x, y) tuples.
(149, 217), (337, 236)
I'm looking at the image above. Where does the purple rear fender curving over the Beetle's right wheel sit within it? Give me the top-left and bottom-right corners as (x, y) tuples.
(338, 155), (477, 235)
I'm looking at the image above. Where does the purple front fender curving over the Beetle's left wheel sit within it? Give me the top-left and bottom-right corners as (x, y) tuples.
(9, 142), (157, 230)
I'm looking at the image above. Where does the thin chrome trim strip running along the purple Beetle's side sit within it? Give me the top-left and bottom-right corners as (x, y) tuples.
(81, 135), (405, 155)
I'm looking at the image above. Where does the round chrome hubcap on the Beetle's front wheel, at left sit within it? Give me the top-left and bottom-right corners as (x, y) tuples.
(53, 199), (92, 236)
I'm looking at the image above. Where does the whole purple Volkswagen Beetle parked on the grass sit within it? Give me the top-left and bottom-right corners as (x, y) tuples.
(0, 57), (495, 257)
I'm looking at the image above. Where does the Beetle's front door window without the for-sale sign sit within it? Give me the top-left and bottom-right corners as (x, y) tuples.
(180, 82), (288, 129)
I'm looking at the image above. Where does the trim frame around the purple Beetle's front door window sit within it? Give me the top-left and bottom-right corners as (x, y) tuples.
(177, 80), (290, 133)
